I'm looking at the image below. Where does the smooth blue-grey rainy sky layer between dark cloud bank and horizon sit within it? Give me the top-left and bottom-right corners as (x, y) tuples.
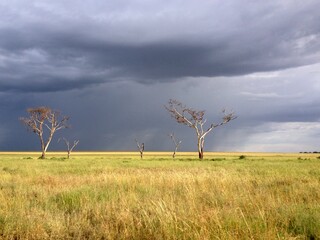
(0, 68), (320, 151)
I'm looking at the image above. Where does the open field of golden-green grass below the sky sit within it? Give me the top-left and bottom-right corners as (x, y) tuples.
(0, 152), (320, 240)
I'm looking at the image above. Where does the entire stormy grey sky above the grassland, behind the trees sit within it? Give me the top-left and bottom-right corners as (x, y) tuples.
(0, 0), (320, 152)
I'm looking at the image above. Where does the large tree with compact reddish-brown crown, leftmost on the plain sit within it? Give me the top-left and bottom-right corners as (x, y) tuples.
(20, 107), (69, 159)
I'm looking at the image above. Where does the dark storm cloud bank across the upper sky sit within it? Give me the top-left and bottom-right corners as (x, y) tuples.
(0, 0), (320, 91)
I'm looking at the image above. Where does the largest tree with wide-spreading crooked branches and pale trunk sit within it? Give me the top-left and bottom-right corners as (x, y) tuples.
(165, 99), (237, 159)
